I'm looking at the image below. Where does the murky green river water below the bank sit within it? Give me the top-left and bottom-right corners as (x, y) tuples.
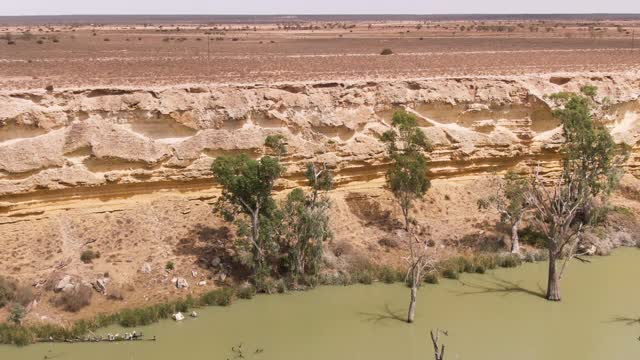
(0, 249), (640, 360)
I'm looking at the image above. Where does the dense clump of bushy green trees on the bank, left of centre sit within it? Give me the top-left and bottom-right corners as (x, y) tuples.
(211, 135), (333, 286)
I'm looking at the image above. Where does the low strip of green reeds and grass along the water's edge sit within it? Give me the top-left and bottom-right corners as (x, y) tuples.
(0, 253), (528, 346)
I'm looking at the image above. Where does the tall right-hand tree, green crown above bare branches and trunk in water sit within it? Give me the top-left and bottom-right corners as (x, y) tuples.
(527, 94), (627, 301)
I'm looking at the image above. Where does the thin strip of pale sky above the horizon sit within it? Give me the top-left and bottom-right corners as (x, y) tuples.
(0, 0), (640, 15)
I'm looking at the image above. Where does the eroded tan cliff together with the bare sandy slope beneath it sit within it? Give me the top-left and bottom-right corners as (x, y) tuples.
(0, 73), (640, 320)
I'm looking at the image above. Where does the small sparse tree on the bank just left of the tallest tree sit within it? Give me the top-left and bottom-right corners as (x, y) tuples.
(478, 171), (529, 254)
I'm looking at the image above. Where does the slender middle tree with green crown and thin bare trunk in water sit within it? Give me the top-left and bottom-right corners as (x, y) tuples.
(381, 111), (431, 323)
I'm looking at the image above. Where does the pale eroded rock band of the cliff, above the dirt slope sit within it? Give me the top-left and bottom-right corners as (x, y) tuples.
(0, 74), (640, 202)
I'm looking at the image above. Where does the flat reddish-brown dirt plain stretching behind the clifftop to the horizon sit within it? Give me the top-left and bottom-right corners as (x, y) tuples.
(0, 20), (640, 90)
